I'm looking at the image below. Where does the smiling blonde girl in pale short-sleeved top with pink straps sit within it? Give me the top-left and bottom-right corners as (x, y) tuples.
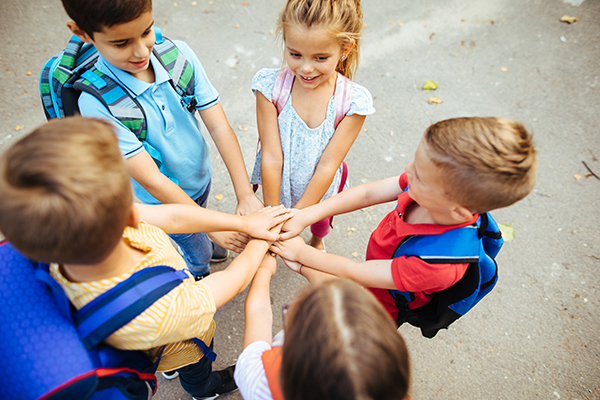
(251, 0), (375, 249)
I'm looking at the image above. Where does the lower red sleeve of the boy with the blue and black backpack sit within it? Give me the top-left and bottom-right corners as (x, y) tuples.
(392, 256), (469, 293)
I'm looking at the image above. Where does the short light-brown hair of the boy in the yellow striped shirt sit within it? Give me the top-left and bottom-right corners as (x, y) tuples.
(0, 117), (133, 264)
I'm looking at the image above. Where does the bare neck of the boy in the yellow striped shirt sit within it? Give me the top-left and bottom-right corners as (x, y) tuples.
(61, 239), (144, 282)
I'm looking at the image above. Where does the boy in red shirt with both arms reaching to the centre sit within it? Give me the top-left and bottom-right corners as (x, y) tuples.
(273, 117), (537, 324)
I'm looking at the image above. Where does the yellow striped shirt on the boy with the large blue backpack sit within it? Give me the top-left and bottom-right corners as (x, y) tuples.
(50, 222), (216, 371)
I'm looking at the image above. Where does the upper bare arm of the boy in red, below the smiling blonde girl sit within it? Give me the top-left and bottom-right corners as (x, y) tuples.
(280, 178), (402, 240)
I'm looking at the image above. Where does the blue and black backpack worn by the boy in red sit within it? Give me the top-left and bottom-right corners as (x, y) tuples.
(389, 213), (504, 338)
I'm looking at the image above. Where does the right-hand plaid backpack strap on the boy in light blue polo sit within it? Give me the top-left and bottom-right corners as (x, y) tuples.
(152, 27), (197, 112)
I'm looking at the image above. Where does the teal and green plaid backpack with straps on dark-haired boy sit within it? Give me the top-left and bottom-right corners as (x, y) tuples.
(40, 27), (197, 178)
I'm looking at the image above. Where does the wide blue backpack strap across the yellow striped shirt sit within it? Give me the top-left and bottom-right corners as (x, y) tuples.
(74, 266), (188, 349)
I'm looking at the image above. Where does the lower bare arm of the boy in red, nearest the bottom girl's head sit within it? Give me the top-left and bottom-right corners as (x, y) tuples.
(271, 237), (396, 289)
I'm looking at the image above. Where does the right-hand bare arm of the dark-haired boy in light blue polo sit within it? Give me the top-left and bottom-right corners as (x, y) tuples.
(199, 103), (262, 215)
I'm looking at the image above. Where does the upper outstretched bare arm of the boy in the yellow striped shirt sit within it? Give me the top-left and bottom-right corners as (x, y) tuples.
(135, 204), (292, 240)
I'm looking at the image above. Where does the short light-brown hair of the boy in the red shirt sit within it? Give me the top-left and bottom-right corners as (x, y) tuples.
(424, 117), (537, 213)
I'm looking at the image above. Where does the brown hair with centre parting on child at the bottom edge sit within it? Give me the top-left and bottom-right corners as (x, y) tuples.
(280, 279), (410, 400)
